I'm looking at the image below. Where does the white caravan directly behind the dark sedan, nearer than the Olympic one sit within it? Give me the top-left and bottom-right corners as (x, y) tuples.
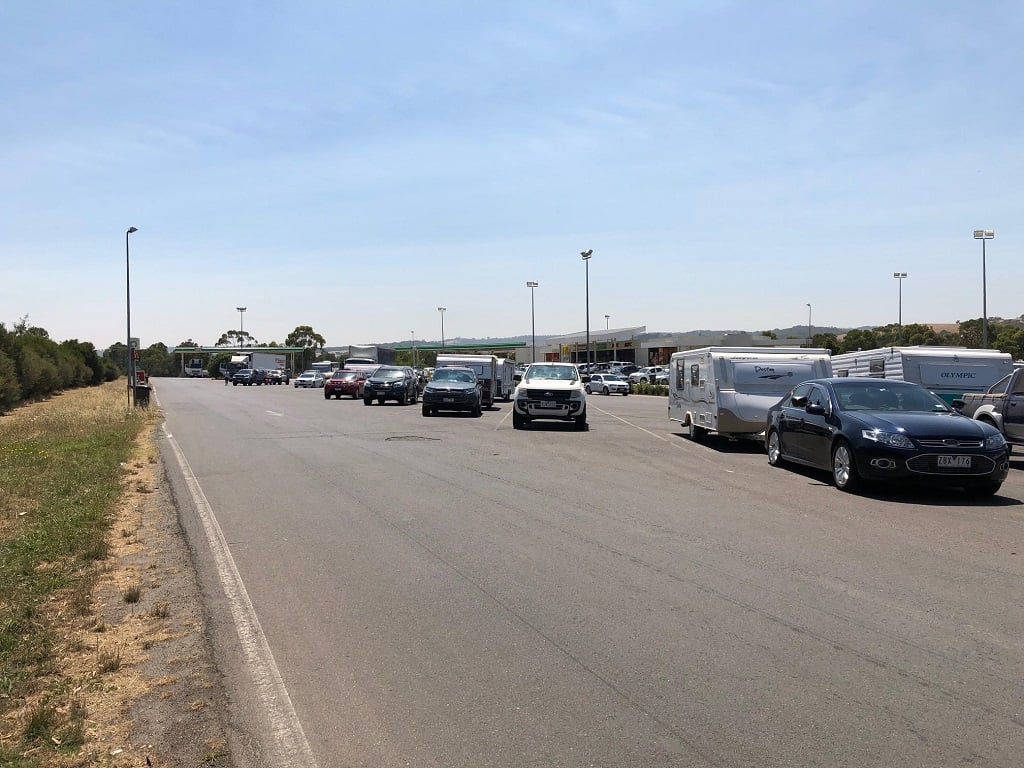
(669, 347), (831, 440)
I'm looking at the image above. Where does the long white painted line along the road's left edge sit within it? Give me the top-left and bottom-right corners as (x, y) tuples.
(164, 428), (317, 768)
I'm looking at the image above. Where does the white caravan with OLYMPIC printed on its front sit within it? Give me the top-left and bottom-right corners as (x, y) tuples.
(833, 346), (1014, 402)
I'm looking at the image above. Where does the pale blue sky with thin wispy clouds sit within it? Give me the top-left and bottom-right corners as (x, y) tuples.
(0, 0), (1024, 347)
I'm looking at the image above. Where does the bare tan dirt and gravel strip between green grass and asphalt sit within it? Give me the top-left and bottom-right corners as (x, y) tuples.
(0, 409), (231, 768)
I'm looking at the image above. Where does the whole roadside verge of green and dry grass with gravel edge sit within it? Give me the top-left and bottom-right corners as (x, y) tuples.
(0, 382), (229, 768)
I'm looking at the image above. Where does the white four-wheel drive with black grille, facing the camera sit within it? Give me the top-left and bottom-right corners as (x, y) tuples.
(512, 362), (587, 429)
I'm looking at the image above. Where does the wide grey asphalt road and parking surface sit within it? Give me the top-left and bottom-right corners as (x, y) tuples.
(157, 379), (1024, 768)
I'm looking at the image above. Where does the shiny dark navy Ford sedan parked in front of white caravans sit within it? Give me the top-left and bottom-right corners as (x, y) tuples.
(765, 378), (1010, 496)
